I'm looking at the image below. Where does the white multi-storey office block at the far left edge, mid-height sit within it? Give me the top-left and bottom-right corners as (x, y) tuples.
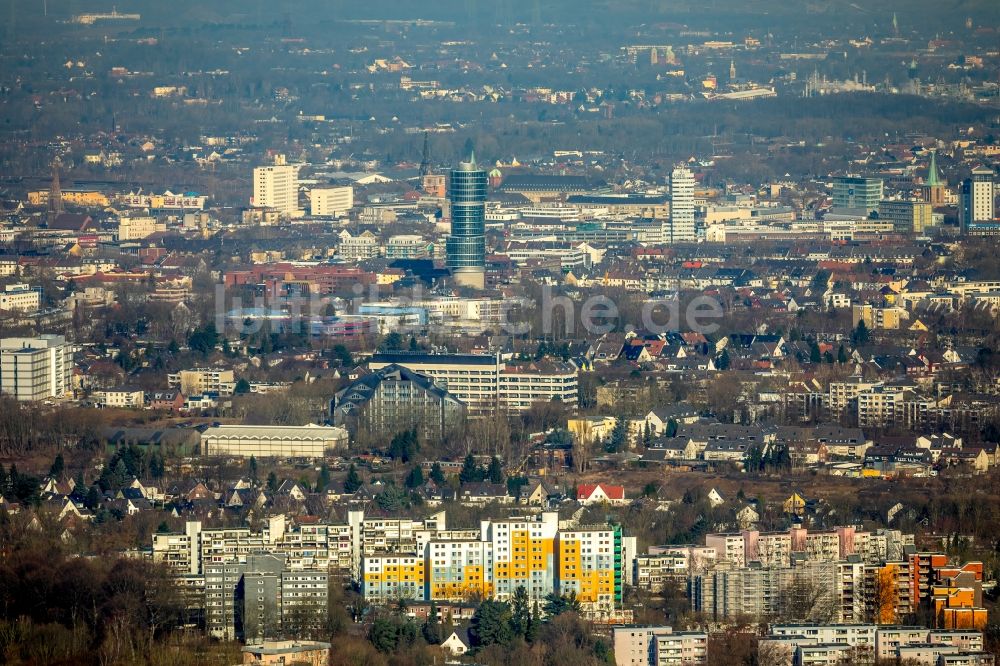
(0, 334), (73, 400)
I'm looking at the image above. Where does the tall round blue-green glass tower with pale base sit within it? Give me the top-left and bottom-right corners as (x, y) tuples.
(446, 154), (487, 289)
